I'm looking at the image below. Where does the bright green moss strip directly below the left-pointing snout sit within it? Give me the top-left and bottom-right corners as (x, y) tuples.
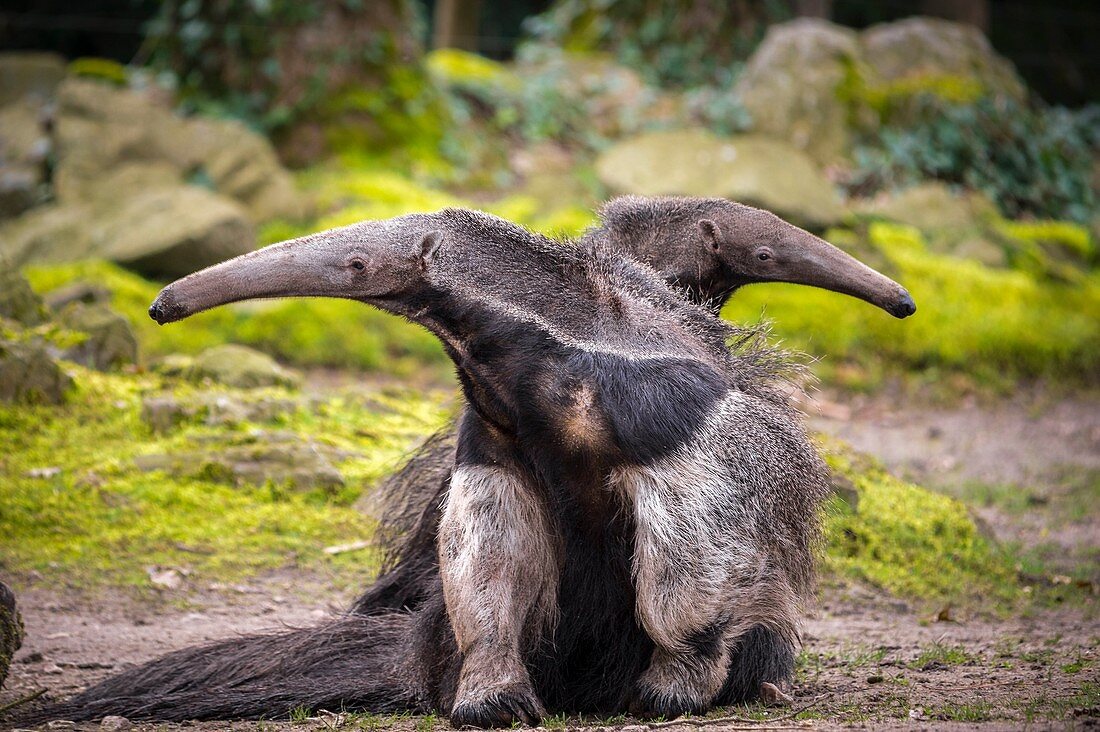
(26, 262), (450, 379)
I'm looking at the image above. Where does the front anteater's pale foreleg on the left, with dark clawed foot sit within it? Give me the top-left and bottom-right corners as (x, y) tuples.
(439, 422), (560, 728)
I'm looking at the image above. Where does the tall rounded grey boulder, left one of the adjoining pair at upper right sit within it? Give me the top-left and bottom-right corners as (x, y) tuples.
(736, 18), (860, 164)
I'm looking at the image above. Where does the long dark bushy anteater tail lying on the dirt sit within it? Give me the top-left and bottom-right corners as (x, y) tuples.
(17, 613), (425, 723)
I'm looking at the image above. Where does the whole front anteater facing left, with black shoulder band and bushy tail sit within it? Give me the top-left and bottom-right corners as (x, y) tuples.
(25, 200), (912, 726)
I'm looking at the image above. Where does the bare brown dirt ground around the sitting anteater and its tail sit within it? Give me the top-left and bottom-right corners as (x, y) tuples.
(0, 387), (1100, 732)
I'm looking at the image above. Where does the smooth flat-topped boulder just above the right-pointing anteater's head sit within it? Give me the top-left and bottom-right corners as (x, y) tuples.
(596, 130), (844, 229)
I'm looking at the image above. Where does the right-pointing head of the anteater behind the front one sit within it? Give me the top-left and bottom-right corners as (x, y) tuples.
(601, 196), (916, 318)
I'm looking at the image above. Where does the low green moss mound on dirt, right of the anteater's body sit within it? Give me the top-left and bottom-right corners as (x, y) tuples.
(825, 443), (1019, 605)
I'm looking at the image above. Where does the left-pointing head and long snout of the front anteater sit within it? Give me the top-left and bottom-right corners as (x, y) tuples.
(149, 215), (443, 325)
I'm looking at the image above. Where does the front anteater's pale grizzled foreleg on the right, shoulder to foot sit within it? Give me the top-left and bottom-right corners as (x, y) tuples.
(616, 442), (796, 718)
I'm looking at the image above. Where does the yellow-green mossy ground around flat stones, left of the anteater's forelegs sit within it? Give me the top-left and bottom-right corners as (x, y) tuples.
(0, 367), (446, 587)
